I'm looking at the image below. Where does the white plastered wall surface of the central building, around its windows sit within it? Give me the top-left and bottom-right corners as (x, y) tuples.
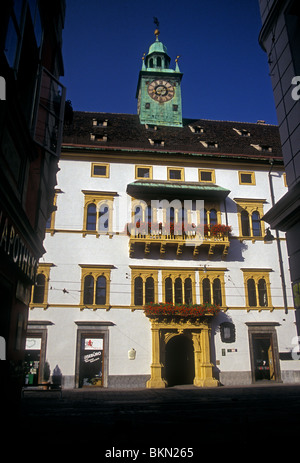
(28, 134), (300, 387)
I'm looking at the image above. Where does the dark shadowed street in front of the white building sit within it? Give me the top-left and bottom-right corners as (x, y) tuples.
(15, 384), (300, 461)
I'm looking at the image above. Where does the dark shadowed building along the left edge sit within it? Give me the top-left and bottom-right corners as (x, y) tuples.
(0, 0), (65, 397)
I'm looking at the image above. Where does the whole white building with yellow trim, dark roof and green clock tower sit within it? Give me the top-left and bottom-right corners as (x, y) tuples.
(27, 31), (299, 388)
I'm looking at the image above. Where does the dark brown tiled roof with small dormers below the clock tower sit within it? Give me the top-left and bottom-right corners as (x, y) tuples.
(62, 111), (282, 161)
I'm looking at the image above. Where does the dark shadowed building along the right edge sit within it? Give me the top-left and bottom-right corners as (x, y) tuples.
(259, 0), (300, 330)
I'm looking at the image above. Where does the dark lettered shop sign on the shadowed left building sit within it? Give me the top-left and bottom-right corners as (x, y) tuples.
(0, 211), (38, 283)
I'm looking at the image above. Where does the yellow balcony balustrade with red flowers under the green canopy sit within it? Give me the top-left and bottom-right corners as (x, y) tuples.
(128, 223), (231, 257)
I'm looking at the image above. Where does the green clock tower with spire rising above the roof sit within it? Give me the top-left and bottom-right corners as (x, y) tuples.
(136, 29), (182, 127)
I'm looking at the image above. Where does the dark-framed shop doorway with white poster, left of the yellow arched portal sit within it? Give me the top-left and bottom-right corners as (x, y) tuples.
(79, 337), (103, 387)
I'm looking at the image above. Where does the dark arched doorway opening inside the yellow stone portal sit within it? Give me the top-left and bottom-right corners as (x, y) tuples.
(165, 334), (195, 386)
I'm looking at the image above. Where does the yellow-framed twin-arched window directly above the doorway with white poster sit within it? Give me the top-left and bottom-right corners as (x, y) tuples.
(80, 264), (113, 310)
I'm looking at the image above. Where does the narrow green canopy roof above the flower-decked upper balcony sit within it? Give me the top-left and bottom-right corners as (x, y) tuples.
(127, 179), (230, 200)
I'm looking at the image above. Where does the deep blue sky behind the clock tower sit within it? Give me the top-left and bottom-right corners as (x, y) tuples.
(61, 0), (277, 124)
